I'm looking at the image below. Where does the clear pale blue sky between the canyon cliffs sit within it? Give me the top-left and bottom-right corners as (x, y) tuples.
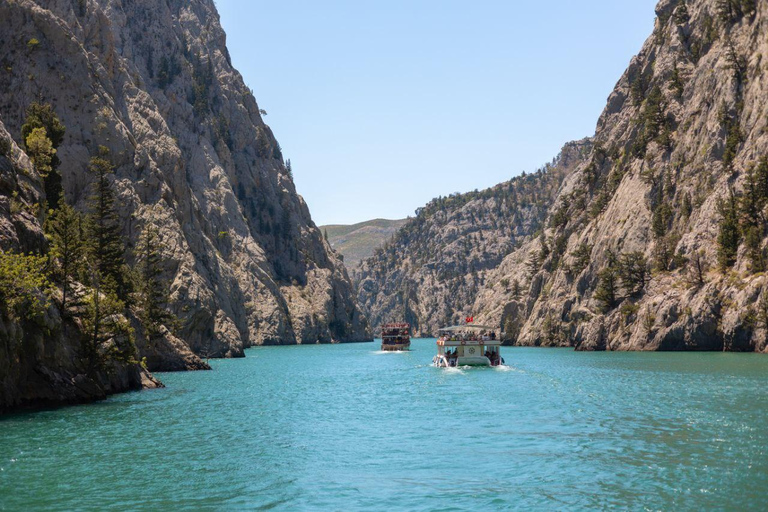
(217, 0), (656, 225)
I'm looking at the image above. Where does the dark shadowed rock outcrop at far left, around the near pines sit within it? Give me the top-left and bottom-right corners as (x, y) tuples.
(0, 121), (161, 413)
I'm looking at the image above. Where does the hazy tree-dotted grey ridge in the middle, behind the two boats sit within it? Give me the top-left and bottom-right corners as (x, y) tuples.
(356, 139), (591, 336)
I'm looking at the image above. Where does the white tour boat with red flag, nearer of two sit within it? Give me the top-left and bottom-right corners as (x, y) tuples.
(432, 325), (504, 368)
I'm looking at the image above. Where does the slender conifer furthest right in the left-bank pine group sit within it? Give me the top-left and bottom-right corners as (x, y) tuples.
(136, 224), (174, 341)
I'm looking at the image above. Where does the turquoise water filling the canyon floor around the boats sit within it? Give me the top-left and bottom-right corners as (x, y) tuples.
(0, 340), (768, 510)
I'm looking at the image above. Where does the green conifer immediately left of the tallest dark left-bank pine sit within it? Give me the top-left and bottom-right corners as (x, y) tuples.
(45, 201), (84, 314)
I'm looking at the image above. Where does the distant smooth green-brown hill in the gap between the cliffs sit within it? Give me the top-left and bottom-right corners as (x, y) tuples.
(320, 219), (406, 271)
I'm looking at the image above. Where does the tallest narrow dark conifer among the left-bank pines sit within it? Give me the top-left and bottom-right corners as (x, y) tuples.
(87, 148), (130, 301)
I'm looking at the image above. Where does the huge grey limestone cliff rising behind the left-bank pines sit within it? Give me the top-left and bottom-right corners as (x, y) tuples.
(0, 0), (370, 360)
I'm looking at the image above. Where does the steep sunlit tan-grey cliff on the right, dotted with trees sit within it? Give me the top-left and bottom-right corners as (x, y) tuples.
(473, 0), (768, 351)
